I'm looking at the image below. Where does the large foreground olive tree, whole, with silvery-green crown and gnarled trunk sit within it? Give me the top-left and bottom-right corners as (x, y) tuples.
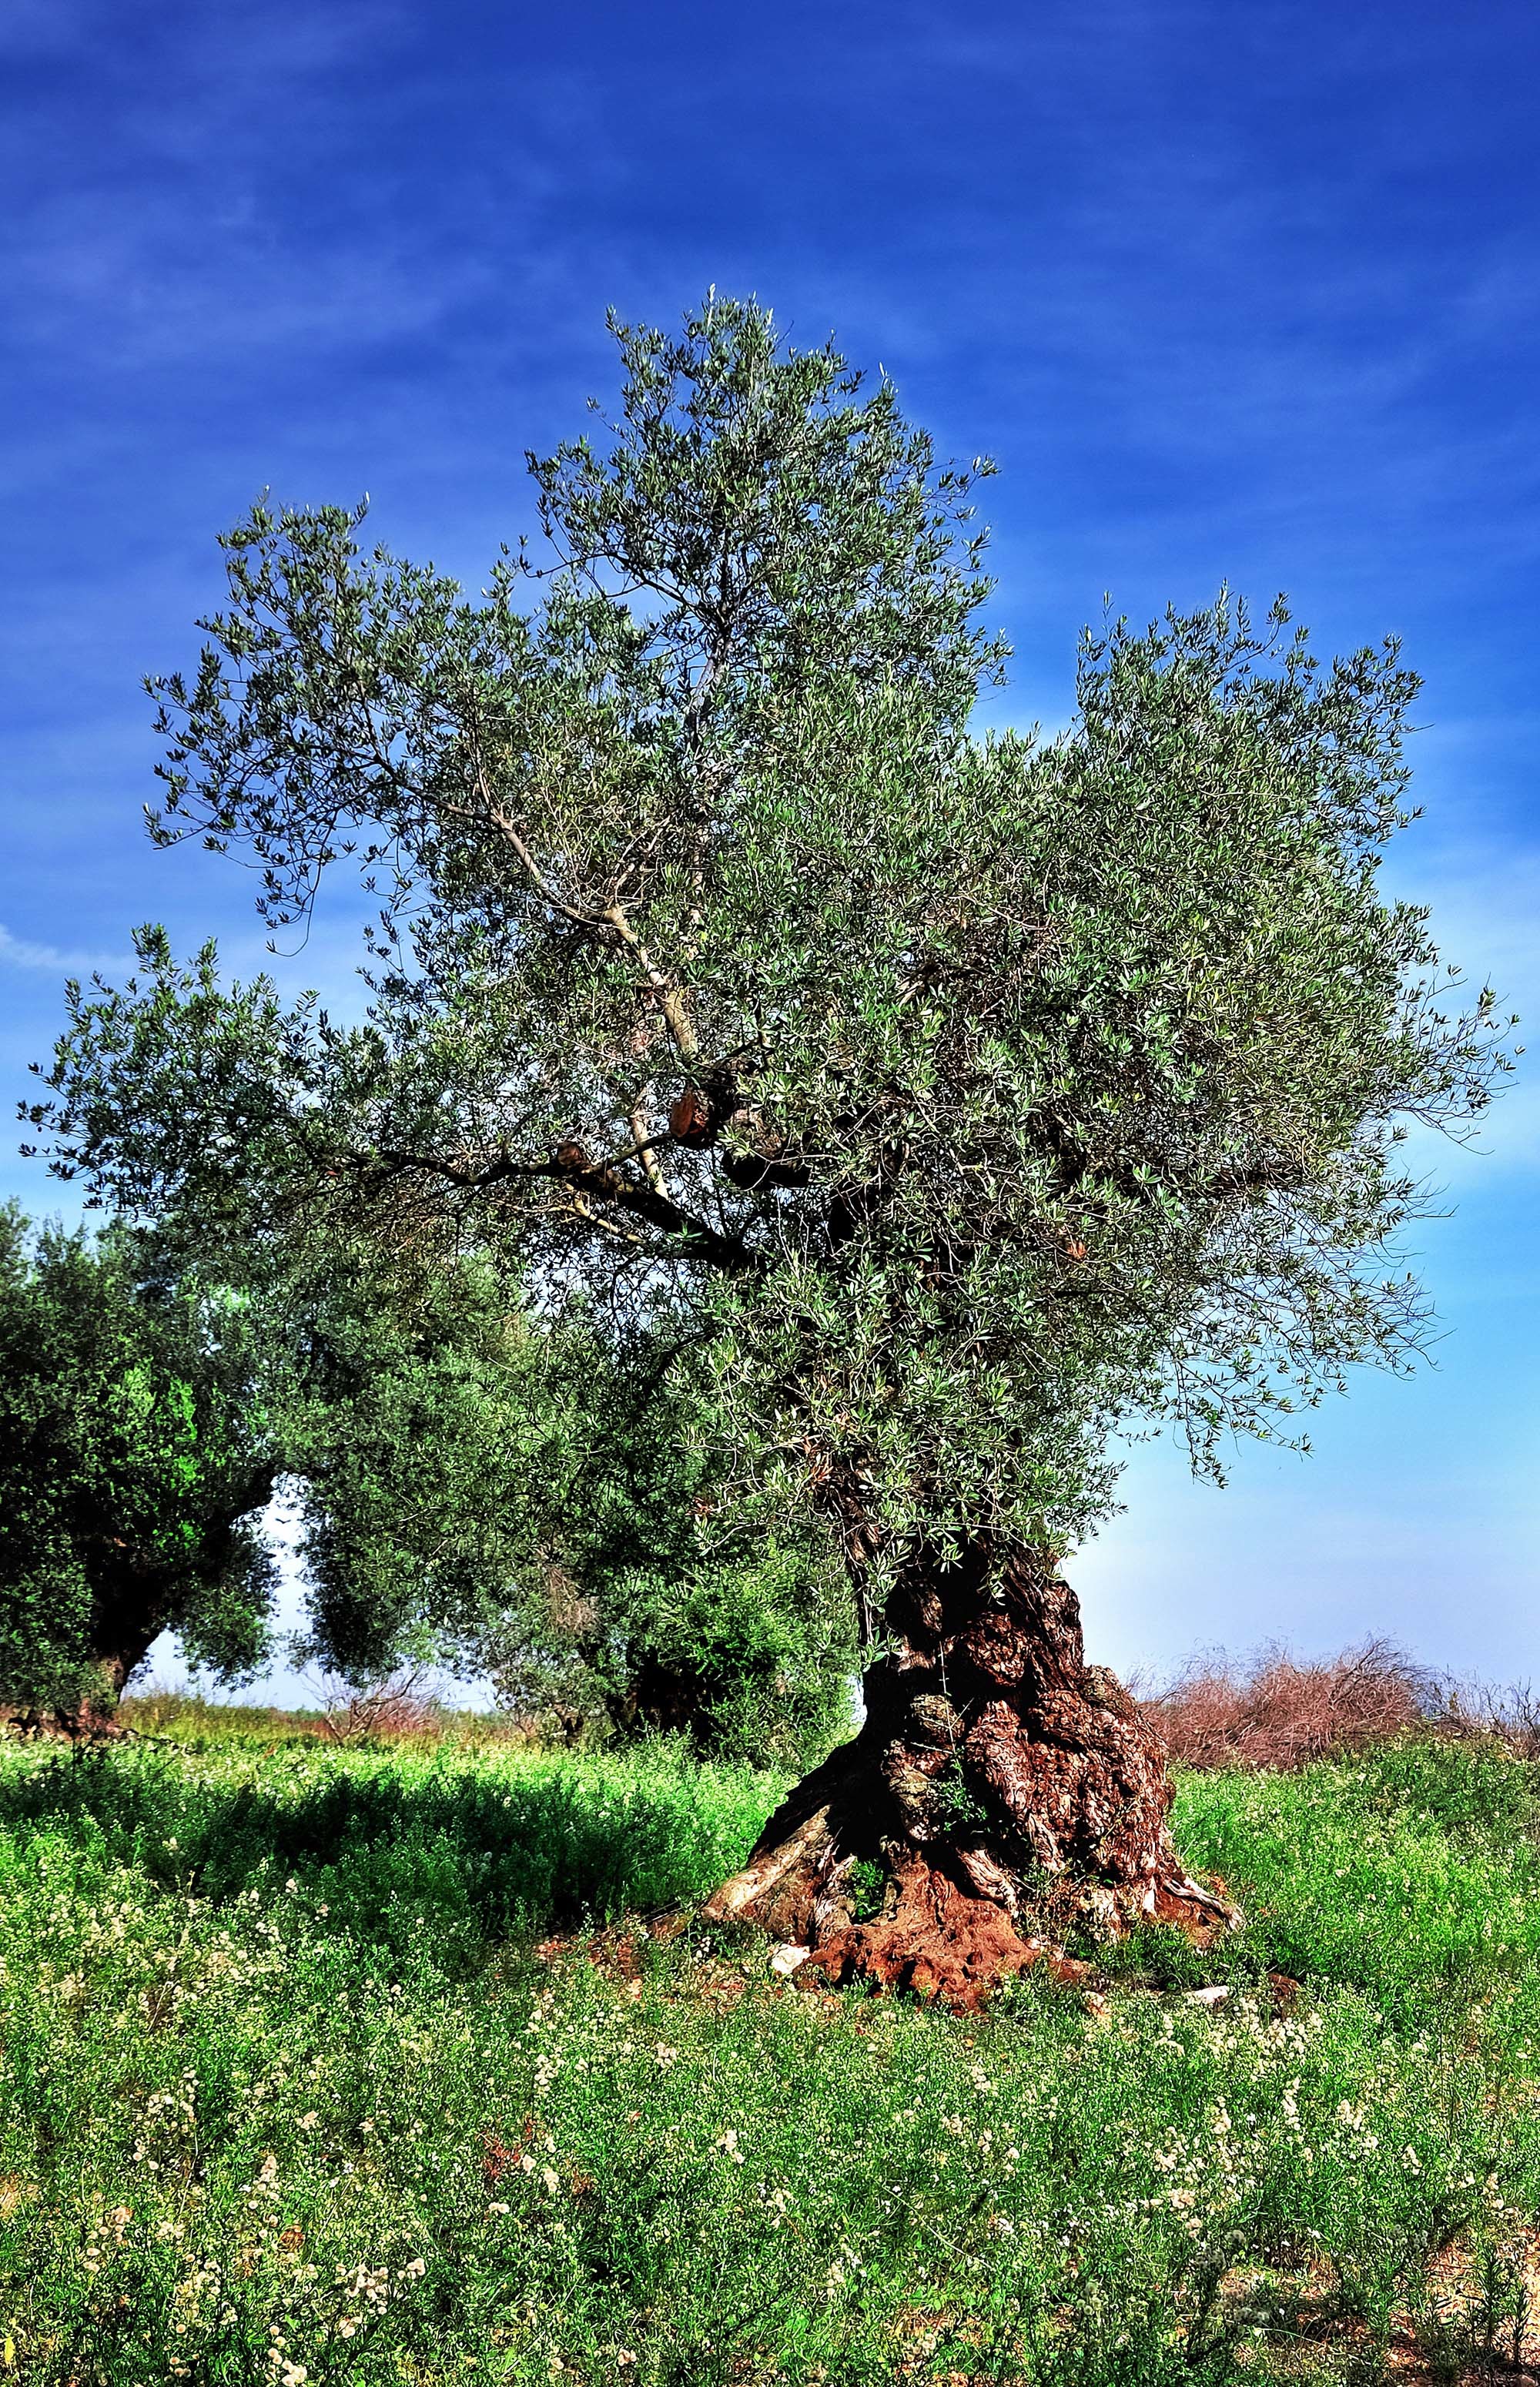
(38, 296), (1504, 1990)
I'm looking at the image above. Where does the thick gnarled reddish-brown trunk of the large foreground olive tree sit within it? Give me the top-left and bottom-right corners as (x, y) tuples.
(707, 1542), (1237, 2005)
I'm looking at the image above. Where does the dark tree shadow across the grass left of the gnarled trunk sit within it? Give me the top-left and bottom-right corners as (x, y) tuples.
(0, 1749), (778, 1970)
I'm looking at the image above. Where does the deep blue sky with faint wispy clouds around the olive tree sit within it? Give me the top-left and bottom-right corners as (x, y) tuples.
(0, 0), (1540, 1676)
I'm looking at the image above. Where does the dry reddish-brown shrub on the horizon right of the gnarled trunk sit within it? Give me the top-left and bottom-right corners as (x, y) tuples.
(1141, 1638), (1445, 1771)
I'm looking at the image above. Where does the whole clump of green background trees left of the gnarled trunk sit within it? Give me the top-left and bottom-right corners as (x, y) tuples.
(0, 1208), (855, 1755)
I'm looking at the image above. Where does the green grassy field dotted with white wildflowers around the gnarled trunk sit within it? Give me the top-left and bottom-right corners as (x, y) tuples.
(0, 1731), (1540, 2387)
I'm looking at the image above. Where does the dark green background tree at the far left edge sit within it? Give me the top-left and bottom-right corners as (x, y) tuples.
(0, 1208), (275, 1709)
